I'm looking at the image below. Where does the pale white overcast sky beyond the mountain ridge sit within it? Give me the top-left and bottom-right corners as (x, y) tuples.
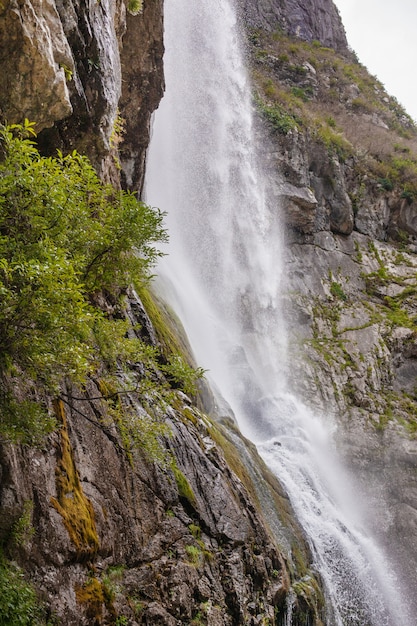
(333, 0), (417, 121)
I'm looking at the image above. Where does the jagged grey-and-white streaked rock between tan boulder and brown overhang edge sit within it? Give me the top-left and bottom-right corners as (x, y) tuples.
(35, 0), (125, 180)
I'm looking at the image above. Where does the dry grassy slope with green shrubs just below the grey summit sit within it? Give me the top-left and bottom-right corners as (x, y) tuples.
(250, 30), (417, 202)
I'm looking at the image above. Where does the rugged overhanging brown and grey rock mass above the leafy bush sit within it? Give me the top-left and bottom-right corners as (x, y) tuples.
(0, 0), (163, 191)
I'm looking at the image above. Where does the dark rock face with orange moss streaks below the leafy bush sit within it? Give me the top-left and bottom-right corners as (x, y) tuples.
(0, 286), (322, 626)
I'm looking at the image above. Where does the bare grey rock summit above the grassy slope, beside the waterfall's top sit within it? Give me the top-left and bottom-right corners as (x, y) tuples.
(239, 0), (348, 52)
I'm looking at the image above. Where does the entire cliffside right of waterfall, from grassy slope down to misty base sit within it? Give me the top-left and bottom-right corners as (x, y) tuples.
(245, 19), (417, 597)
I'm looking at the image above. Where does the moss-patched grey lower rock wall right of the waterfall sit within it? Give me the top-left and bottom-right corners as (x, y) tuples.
(285, 231), (417, 604)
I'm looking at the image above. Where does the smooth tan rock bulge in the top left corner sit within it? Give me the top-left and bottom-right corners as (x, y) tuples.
(0, 0), (74, 130)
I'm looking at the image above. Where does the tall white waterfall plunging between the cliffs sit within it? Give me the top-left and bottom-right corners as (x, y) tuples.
(146, 0), (411, 626)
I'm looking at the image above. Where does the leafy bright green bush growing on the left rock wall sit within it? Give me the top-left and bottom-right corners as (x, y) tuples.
(0, 121), (166, 440)
